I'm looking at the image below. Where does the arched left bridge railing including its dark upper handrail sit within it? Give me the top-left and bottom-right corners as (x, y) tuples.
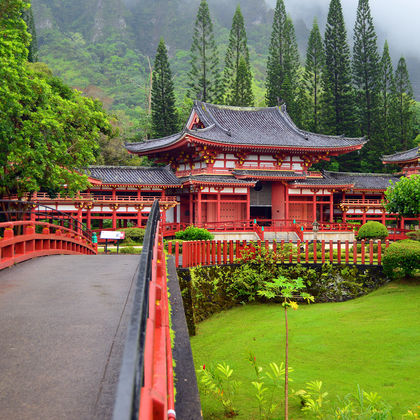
(0, 200), (97, 269)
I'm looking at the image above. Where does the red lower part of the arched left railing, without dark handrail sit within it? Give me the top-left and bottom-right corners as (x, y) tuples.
(0, 221), (97, 269)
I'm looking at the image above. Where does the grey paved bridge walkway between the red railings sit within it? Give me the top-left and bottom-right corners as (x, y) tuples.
(0, 256), (139, 420)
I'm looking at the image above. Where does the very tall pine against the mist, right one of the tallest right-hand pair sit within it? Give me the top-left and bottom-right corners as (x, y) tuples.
(353, 0), (380, 139)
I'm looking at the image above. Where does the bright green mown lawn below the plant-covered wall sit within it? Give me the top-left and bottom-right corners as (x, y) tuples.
(191, 281), (420, 419)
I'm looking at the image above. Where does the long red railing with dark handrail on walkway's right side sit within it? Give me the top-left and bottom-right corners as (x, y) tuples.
(113, 201), (175, 420)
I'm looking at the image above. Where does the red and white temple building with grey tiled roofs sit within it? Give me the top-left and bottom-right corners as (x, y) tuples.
(15, 101), (420, 230)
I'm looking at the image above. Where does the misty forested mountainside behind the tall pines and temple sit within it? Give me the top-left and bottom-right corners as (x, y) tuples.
(22, 0), (420, 170)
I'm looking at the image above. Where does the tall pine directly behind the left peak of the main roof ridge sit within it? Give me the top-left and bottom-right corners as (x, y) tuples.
(188, 0), (222, 103)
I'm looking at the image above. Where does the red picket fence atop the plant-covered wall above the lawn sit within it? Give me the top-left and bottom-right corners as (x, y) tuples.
(168, 240), (389, 268)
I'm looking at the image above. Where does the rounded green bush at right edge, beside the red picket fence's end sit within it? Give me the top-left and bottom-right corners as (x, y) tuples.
(382, 239), (420, 278)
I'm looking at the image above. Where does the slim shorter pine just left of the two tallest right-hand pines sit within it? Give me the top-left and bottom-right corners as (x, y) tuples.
(305, 19), (325, 132)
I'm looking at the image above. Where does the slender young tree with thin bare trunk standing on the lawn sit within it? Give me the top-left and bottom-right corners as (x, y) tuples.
(258, 276), (314, 420)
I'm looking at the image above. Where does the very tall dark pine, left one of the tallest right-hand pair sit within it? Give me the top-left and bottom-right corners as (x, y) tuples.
(323, 0), (354, 135)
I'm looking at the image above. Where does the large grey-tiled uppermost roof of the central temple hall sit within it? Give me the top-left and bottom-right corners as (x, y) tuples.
(125, 101), (367, 154)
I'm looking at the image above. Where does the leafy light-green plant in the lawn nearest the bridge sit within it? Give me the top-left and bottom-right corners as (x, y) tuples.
(197, 363), (240, 417)
